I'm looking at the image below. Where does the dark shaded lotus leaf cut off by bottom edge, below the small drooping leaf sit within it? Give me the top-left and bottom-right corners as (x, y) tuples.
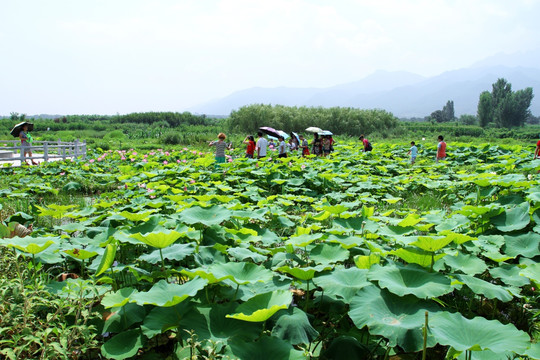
(229, 336), (306, 360)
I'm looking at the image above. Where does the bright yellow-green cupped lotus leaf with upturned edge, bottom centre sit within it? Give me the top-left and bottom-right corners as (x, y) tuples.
(227, 290), (292, 322)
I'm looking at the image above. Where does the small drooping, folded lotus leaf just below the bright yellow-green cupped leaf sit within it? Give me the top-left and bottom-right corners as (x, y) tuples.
(272, 307), (319, 345)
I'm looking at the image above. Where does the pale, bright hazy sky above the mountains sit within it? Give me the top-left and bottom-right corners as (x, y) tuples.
(0, 0), (540, 115)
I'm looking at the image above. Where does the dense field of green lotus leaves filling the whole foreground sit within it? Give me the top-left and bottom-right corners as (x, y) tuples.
(0, 143), (540, 360)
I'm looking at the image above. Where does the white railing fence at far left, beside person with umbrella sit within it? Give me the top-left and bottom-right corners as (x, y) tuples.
(0, 140), (86, 164)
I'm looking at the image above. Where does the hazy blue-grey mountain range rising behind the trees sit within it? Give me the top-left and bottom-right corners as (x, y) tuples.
(189, 50), (540, 118)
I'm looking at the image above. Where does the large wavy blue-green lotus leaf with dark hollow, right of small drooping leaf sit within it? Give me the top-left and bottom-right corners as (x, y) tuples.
(349, 285), (439, 352)
